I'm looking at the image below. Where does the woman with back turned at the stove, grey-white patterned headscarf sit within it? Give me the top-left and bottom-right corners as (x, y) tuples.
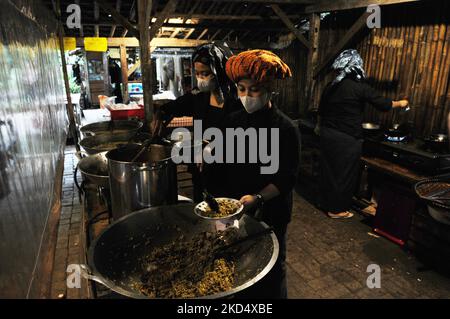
(317, 49), (408, 218)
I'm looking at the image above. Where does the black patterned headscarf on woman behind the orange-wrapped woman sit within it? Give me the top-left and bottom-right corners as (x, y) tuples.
(192, 42), (236, 99)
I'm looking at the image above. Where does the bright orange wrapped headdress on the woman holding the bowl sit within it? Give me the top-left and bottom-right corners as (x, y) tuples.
(226, 50), (292, 83)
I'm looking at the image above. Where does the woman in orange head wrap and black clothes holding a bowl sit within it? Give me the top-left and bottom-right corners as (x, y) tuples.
(226, 50), (300, 298)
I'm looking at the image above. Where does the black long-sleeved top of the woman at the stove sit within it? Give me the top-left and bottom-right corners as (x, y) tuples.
(319, 78), (392, 139)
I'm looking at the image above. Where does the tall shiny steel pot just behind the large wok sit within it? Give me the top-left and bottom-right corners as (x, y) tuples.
(106, 145), (178, 220)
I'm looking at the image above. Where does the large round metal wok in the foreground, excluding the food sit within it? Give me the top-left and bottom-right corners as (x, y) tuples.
(83, 204), (279, 299)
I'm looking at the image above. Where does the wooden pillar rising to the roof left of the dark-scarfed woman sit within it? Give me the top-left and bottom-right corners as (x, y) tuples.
(138, 0), (153, 130)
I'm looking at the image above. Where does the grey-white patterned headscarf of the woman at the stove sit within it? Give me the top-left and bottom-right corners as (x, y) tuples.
(331, 49), (366, 85)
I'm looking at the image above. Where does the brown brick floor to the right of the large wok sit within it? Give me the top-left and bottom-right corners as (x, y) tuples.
(287, 194), (450, 298)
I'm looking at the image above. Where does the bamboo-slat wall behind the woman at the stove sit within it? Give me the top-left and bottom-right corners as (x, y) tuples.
(304, 0), (450, 135)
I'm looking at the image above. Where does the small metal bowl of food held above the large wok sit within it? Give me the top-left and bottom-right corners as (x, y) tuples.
(194, 197), (244, 229)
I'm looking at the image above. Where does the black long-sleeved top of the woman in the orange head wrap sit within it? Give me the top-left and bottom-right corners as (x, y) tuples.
(225, 106), (300, 226)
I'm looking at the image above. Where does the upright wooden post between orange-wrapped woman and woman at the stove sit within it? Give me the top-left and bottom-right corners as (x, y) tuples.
(305, 13), (320, 109)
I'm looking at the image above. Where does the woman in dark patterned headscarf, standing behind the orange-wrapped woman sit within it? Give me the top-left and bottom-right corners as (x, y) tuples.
(152, 43), (239, 202)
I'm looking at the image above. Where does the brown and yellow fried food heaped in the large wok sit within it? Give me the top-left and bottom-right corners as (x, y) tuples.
(134, 232), (235, 298)
